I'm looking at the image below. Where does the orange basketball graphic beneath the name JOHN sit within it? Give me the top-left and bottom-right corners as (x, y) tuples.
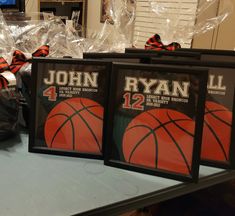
(44, 98), (104, 154)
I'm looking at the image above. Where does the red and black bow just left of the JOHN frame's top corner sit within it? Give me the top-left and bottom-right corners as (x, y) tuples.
(10, 45), (49, 74)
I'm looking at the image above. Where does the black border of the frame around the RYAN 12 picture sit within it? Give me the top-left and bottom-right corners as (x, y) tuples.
(104, 63), (208, 182)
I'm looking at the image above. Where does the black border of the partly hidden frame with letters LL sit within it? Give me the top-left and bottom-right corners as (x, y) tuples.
(151, 58), (235, 169)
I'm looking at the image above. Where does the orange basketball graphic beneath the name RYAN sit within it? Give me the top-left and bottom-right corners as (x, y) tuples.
(122, 109), (195, 175)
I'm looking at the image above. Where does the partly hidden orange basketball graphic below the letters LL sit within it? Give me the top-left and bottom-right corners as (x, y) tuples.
(201, 101), (232, 162)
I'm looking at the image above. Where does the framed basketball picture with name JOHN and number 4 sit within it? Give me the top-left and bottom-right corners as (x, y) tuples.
(29, 58), (111, 159)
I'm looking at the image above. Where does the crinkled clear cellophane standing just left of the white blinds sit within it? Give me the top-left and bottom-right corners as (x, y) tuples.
(77, 0), (136, 52)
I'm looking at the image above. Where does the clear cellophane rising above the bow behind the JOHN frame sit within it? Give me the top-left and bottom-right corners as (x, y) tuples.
(5, 13), (82, 58)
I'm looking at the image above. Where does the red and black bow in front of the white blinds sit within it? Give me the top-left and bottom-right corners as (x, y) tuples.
(145, 34), (181, 51)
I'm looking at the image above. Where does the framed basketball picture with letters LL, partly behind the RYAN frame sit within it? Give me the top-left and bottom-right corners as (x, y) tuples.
(152, 58), (235, 169)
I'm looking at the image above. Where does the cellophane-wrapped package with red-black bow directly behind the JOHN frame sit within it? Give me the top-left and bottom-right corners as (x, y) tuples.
(4, 13), (82, 127)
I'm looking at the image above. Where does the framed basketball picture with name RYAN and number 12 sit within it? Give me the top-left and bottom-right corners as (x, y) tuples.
(104, 63), (208, 181)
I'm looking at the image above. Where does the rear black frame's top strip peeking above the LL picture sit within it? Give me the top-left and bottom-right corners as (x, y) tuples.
(177, 48), (235, 62)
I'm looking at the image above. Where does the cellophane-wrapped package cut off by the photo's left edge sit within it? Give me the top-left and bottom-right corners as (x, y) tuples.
(0, 11), (19, 141)
